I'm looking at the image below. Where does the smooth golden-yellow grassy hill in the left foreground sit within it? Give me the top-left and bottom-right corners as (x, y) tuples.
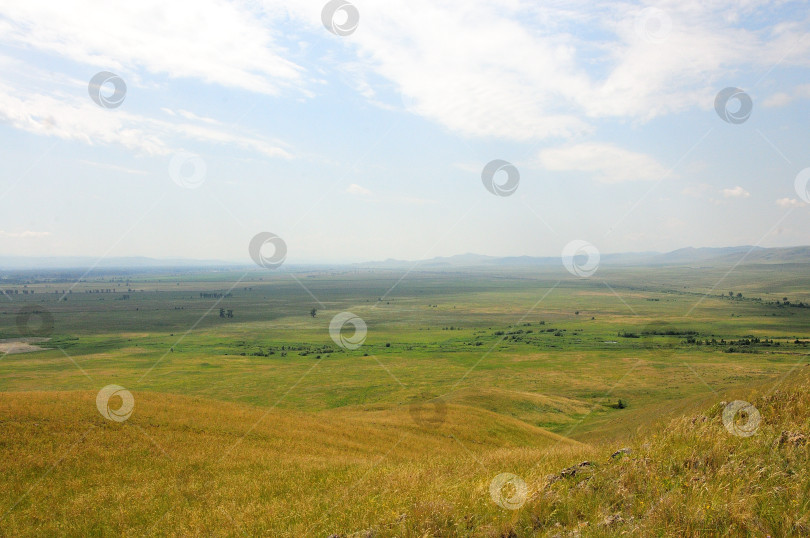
(0, 392), (587, 536)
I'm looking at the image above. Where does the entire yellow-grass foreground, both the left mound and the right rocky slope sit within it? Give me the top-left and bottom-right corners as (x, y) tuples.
(0, 374), (810, 536)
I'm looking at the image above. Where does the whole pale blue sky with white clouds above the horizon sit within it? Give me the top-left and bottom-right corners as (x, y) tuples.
(0, 0), (810, 263)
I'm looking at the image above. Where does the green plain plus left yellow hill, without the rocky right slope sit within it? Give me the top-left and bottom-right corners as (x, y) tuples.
(0, 264), (810, 536)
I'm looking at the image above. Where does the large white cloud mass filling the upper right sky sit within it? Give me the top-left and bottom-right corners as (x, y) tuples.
(340, 0), (810, 140)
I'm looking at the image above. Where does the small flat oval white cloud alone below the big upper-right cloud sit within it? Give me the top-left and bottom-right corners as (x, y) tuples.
(538, 142), (668, 183)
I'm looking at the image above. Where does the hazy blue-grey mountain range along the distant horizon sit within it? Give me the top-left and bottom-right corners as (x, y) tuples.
(0, 246), (810, 271)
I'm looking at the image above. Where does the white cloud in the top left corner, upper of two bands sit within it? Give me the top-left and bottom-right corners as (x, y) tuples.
(0, 0), (303, 95)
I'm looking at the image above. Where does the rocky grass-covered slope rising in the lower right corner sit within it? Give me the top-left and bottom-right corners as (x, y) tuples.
(514, 374), (810, 536)
